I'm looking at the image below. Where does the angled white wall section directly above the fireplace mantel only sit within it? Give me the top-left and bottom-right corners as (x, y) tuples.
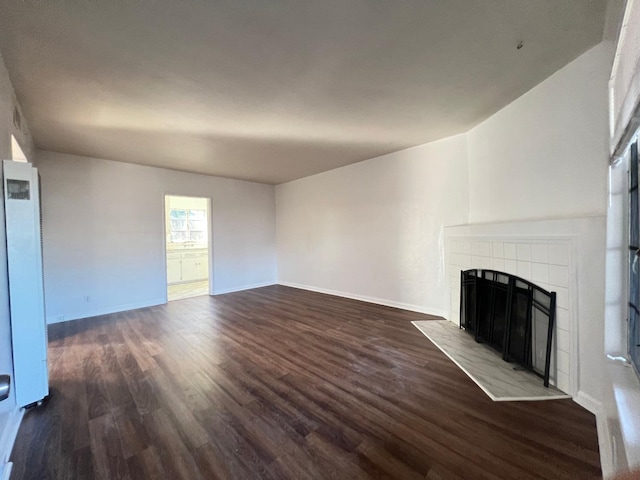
(468, 44), (610, 223)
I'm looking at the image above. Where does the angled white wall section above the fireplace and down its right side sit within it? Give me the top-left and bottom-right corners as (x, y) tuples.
(468, 44), (611, 408)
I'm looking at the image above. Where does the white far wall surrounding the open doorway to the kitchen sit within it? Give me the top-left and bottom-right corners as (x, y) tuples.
(37, 150), (276, 322)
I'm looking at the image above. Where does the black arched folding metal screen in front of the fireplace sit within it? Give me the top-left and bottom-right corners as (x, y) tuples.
(460, 270), (556, 387)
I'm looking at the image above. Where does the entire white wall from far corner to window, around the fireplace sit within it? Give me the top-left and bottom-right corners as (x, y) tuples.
(276, 44), (611, 410)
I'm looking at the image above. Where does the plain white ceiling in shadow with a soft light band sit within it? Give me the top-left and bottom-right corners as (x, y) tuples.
(0, 0), (605, 184)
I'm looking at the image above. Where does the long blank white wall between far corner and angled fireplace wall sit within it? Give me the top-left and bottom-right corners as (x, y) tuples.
(276, 135), (468, 314)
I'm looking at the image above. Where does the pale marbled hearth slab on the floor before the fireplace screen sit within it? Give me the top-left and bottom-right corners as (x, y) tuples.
(412, 320), (571, 402)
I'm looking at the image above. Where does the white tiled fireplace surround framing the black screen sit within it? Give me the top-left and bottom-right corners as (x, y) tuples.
(444, 217), (605, 413)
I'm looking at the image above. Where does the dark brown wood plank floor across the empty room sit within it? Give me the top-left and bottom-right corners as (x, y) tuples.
(12, 286), (601, 480)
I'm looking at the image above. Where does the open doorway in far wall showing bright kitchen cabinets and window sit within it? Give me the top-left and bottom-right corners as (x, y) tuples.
(164, 195), (211, 301)
